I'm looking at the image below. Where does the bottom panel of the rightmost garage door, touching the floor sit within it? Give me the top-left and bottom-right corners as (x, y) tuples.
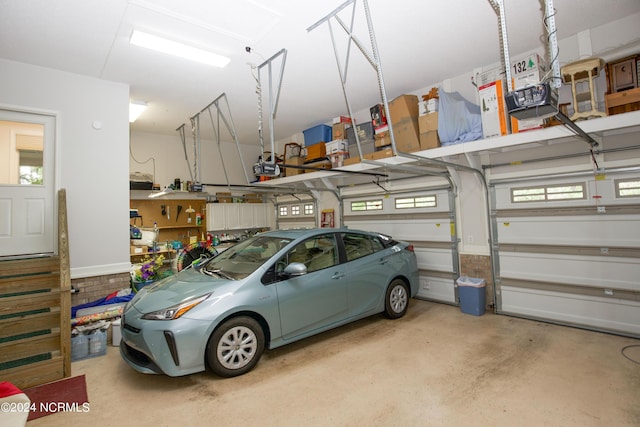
(501, 286), (640, 335)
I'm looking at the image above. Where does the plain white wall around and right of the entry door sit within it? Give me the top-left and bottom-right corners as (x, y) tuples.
(0, 59), (130, 279)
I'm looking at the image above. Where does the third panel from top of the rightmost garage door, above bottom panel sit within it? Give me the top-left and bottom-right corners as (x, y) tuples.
(500, 252), (640, 292)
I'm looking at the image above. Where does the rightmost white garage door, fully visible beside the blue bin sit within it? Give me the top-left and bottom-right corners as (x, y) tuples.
(491, 172), (640, 336)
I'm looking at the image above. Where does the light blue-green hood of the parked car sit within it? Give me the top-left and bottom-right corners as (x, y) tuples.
(129, 269), (240, 313)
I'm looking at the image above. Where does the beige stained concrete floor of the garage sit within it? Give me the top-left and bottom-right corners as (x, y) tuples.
(28, 300), (640, 427)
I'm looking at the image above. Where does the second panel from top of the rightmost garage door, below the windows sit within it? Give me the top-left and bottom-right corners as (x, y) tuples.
(497, 215), (640, 247)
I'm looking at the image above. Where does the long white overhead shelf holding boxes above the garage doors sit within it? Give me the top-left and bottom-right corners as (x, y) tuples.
(260, 111), (640, 185)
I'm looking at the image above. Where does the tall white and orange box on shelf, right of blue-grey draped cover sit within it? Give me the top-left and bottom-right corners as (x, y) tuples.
(477, 68), (509, 138)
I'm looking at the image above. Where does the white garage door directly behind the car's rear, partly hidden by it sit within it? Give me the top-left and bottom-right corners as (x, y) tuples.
(343, 188), (459, 304)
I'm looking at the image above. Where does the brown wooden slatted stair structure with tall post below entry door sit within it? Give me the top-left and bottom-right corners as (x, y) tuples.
(0, 190), (71, 389)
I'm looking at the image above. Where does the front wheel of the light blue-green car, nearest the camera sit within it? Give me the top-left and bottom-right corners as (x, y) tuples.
(207, 317), (264, 378)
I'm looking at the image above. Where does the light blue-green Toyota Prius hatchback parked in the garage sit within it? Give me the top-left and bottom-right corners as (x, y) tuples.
(120, 228), (418, 377)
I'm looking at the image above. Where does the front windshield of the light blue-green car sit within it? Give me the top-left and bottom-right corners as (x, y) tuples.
(201, 235), (291, 280)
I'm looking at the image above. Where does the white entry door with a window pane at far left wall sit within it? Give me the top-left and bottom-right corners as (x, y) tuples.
(0, 108), (57, 257)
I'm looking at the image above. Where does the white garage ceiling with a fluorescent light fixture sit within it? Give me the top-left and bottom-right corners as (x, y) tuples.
(0, 0), (640, 144)
